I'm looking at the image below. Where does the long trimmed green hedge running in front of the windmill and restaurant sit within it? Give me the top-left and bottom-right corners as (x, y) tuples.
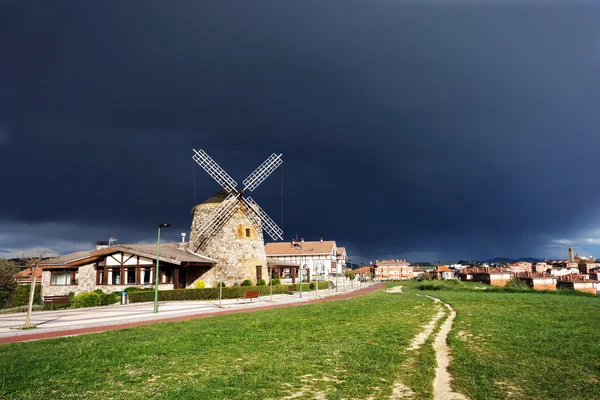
(127, 282), (327, 303)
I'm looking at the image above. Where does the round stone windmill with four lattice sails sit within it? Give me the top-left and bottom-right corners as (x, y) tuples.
(189, 149), (283, 285)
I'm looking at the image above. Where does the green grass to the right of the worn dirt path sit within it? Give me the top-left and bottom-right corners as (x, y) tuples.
(400, 283), (600, 400)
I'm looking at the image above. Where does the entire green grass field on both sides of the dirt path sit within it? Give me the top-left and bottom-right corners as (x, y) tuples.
(0, 282), (600, 400)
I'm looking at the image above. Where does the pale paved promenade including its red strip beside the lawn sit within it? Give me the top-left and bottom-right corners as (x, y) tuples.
(0, 284), (383, 344)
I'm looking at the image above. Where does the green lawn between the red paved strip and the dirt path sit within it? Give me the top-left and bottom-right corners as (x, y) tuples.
(0, 291), (438, 399)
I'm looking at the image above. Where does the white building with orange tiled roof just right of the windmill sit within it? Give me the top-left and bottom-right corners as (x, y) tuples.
(265, 239), (348, 280)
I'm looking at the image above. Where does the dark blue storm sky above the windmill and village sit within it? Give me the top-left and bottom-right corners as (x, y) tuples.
(0, 0), (600, 262)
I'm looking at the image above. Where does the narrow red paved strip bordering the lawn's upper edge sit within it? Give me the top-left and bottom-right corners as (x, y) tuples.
(0, 283), (385, 344)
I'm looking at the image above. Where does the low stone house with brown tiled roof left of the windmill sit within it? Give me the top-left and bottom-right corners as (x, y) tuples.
(40, 243), (216, 296)
